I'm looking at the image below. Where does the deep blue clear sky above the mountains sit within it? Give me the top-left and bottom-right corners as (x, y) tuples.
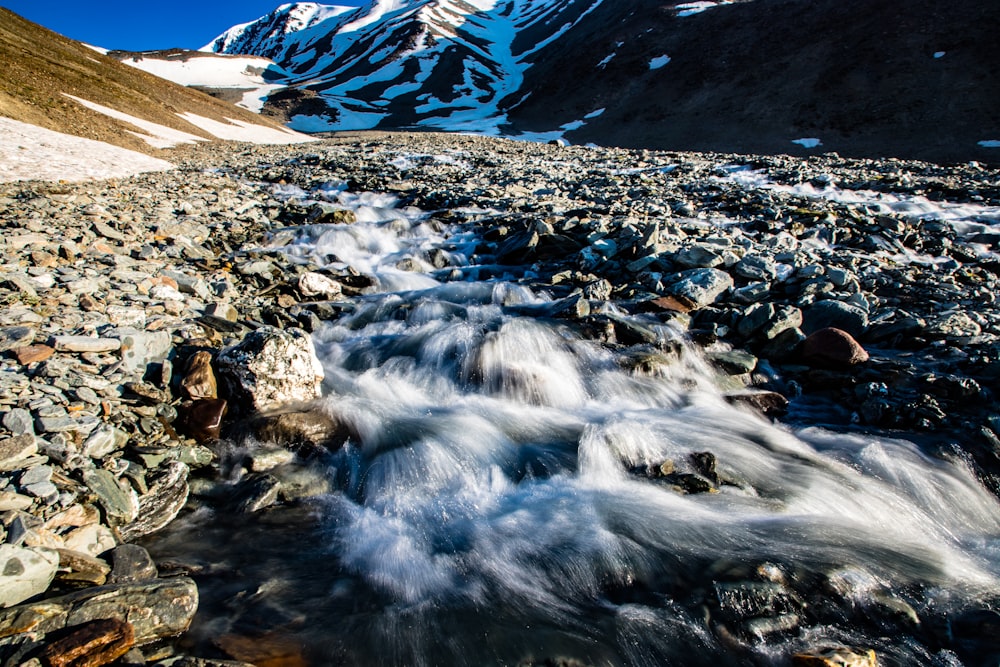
(0, 0), (362, 51)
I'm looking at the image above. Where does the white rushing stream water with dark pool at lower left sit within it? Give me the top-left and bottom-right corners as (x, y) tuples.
(150, 180), (1000, 665)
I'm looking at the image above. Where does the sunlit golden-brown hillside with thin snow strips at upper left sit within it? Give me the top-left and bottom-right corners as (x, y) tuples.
(0, 8), (308, 154)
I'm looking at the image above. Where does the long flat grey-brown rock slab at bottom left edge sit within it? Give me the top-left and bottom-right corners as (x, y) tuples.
(0, 580), (198, 646)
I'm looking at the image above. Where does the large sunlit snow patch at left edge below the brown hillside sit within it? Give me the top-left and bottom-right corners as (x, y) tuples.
(0, 117), (174, 183)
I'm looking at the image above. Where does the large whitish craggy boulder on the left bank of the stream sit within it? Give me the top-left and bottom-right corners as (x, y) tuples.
(217, 327), (323, 412)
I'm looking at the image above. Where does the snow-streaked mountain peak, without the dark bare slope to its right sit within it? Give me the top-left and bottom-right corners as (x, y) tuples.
(205, 0), (610, 131)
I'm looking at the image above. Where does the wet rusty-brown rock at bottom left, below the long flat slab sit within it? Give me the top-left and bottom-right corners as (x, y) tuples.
(40, 618), (135, 667)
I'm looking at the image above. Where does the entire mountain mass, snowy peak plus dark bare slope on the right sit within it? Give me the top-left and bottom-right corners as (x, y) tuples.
(204, 0), (1000, 160)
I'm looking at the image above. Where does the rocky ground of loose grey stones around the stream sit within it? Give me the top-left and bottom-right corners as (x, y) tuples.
(0, 134), (1000, 665)
